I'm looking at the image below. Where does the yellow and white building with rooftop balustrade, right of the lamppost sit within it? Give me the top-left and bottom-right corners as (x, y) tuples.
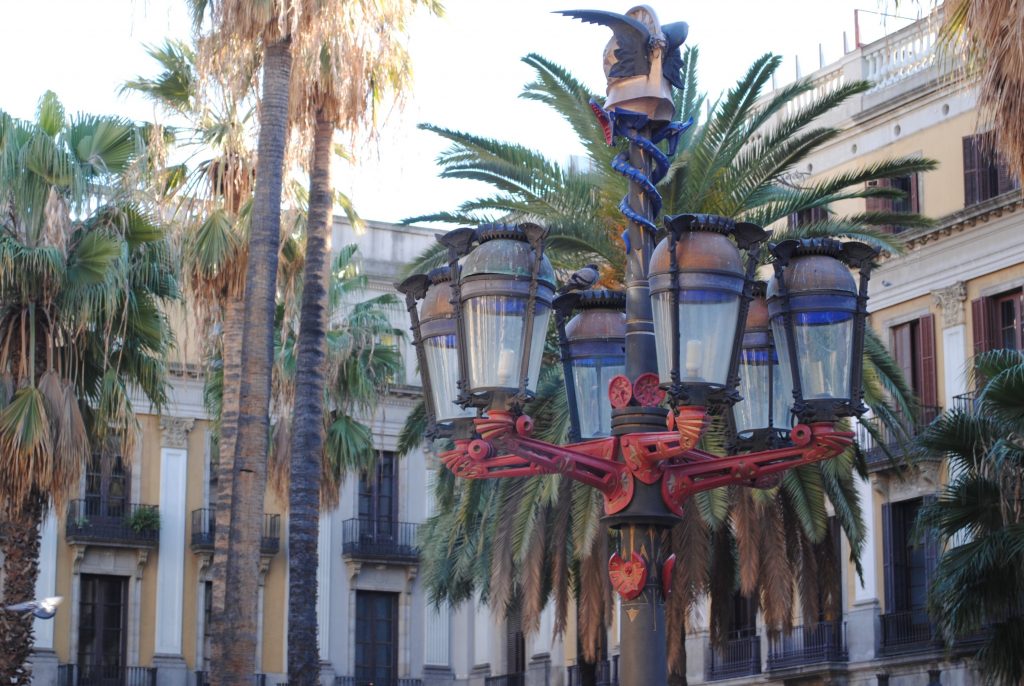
(671, 14), (1024, 686)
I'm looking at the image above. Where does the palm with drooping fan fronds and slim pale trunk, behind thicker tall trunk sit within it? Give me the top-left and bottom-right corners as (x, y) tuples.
(123, 41), (256, 683)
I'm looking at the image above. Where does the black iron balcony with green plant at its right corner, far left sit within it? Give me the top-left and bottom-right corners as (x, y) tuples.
(65, 498), (160, 548)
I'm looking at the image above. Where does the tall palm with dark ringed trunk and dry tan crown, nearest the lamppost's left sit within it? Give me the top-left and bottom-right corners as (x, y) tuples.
(288, 0), (440, 686)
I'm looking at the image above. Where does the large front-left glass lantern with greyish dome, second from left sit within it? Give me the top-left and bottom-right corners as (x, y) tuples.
(458, 224), (555, 398)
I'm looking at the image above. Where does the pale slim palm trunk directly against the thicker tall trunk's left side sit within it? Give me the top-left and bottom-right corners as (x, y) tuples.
(210, 293), (245, 614)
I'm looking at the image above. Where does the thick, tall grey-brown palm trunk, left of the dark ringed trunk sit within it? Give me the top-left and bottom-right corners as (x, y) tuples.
(211, 38), (292, 686)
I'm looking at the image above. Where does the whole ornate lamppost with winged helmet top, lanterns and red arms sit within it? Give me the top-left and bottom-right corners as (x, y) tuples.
(397, 7), (876, 686)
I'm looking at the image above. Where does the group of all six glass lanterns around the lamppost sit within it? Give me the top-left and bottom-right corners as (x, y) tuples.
(397, 223), (877, 452)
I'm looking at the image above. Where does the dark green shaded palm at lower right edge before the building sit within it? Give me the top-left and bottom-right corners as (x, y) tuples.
(919, 350), (1024, 686)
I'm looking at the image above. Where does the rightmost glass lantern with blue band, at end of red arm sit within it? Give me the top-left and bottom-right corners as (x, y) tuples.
(767, 239), (878, 422)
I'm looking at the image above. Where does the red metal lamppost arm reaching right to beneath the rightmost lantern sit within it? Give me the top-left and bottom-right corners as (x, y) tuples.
(662, 423), (853, 516)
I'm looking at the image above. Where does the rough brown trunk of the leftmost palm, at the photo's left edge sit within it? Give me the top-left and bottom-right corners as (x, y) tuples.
(0, 491), (47, 686)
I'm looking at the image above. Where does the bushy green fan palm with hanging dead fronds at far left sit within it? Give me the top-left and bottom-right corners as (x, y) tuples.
(0, 92), (178, 684)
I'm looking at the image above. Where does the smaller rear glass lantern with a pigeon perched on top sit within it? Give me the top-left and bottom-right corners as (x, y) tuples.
(554, 290), (626, 442)
